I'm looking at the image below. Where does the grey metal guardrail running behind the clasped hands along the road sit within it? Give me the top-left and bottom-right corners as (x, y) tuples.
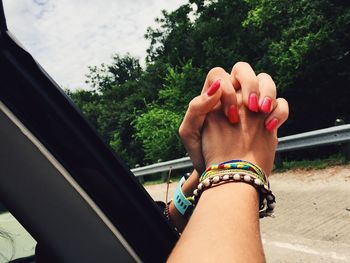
(131, 124), (350, 176)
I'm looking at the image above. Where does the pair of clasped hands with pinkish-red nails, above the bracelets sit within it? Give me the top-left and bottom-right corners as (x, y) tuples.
(179, 62), (288, 175)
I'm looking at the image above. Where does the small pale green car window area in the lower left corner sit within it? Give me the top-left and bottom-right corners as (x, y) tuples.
(0, 207), (36, 263)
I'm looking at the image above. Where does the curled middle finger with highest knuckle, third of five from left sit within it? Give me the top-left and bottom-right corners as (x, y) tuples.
(231, 62), (260, 112)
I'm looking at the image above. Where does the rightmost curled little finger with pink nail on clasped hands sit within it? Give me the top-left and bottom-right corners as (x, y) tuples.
(265, 98), (289, 132)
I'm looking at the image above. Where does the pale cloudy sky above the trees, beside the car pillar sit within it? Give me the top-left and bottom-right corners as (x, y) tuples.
(3, 0), (188, 90)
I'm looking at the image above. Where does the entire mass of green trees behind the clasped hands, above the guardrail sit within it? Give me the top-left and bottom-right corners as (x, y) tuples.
(69, 0), (350, 166)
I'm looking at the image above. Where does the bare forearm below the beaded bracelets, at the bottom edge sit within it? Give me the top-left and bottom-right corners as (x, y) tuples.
(168, 183), (265, 262)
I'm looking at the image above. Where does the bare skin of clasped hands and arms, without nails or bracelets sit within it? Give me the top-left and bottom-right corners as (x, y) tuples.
(168, 62), (288, 262)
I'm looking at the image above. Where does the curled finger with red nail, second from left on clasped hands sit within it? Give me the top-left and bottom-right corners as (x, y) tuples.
(202, 67), (239, 123)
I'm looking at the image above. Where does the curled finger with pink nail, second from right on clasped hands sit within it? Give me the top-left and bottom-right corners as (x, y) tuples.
(257, 73), (276, 113)
